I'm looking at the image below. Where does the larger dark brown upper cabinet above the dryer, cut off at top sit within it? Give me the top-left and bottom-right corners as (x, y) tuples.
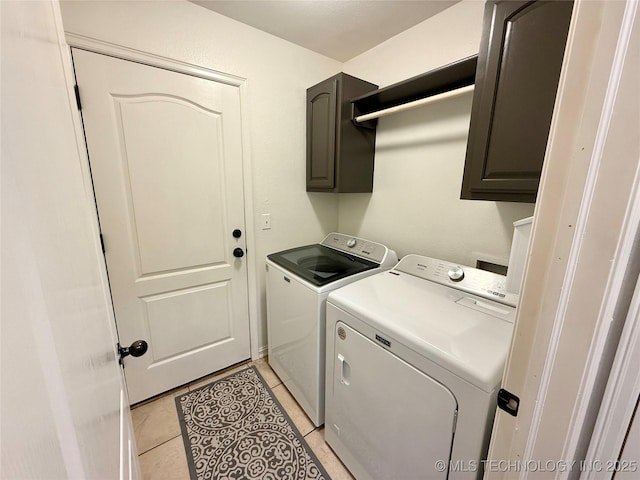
(461, 0), (573, 202)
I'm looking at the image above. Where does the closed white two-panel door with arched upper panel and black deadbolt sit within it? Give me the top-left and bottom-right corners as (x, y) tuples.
(73, 49), (250, 403)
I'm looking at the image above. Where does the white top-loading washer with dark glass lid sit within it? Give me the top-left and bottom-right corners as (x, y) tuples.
(266, 233), (398, 426)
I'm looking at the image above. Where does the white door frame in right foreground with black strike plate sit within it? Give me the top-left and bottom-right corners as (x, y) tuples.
(485, 0), (640, 479)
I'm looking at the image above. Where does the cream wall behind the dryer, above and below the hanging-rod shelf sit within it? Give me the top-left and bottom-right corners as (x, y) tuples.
(338, 1), (534, 265)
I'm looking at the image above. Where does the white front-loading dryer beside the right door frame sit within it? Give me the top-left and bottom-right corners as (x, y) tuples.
(325, 255), (518, 480)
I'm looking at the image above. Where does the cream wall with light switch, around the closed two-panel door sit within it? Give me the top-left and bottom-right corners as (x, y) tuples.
(62, 0), (341, 352)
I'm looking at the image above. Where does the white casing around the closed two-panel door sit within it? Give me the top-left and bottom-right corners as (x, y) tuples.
(65, 32), (263, 360)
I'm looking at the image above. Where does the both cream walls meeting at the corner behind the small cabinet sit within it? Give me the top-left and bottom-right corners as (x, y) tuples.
(62, 0), (533, 356)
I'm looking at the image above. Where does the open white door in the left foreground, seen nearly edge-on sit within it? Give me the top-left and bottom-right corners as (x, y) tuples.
(0, 1), (139, 480)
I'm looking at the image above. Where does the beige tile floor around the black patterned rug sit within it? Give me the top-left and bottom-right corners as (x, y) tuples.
(131, 358), (353, 480)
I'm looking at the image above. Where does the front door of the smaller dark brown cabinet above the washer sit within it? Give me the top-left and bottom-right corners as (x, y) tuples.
(307, 78), (338, 189)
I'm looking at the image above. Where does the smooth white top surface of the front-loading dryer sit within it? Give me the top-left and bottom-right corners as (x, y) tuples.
(328, 264), (515, 392)
